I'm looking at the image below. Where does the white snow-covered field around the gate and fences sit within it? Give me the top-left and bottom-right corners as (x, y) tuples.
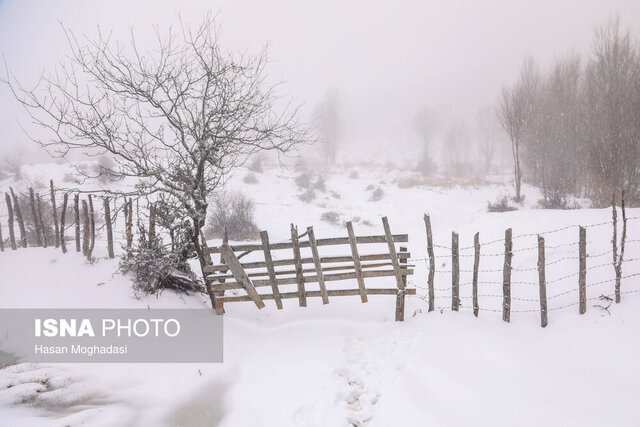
(0, 165), (640, 426)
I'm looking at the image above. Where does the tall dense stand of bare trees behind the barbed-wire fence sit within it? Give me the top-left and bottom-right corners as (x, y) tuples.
(498, 19), (640, 208)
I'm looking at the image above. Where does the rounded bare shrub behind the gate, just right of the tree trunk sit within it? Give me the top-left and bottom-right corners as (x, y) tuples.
(205, 192), (260, 240)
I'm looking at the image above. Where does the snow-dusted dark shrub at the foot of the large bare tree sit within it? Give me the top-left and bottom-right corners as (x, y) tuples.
(118, 227), (204, 297)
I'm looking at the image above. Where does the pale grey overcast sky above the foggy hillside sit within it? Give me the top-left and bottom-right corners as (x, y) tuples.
(0, 0), (640, 160)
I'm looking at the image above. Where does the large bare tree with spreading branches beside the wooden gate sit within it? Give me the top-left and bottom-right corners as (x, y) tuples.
(4, 16), (307, 304)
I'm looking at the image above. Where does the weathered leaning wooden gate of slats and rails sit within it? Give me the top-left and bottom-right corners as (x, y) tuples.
(205, 217), (416, 321)
